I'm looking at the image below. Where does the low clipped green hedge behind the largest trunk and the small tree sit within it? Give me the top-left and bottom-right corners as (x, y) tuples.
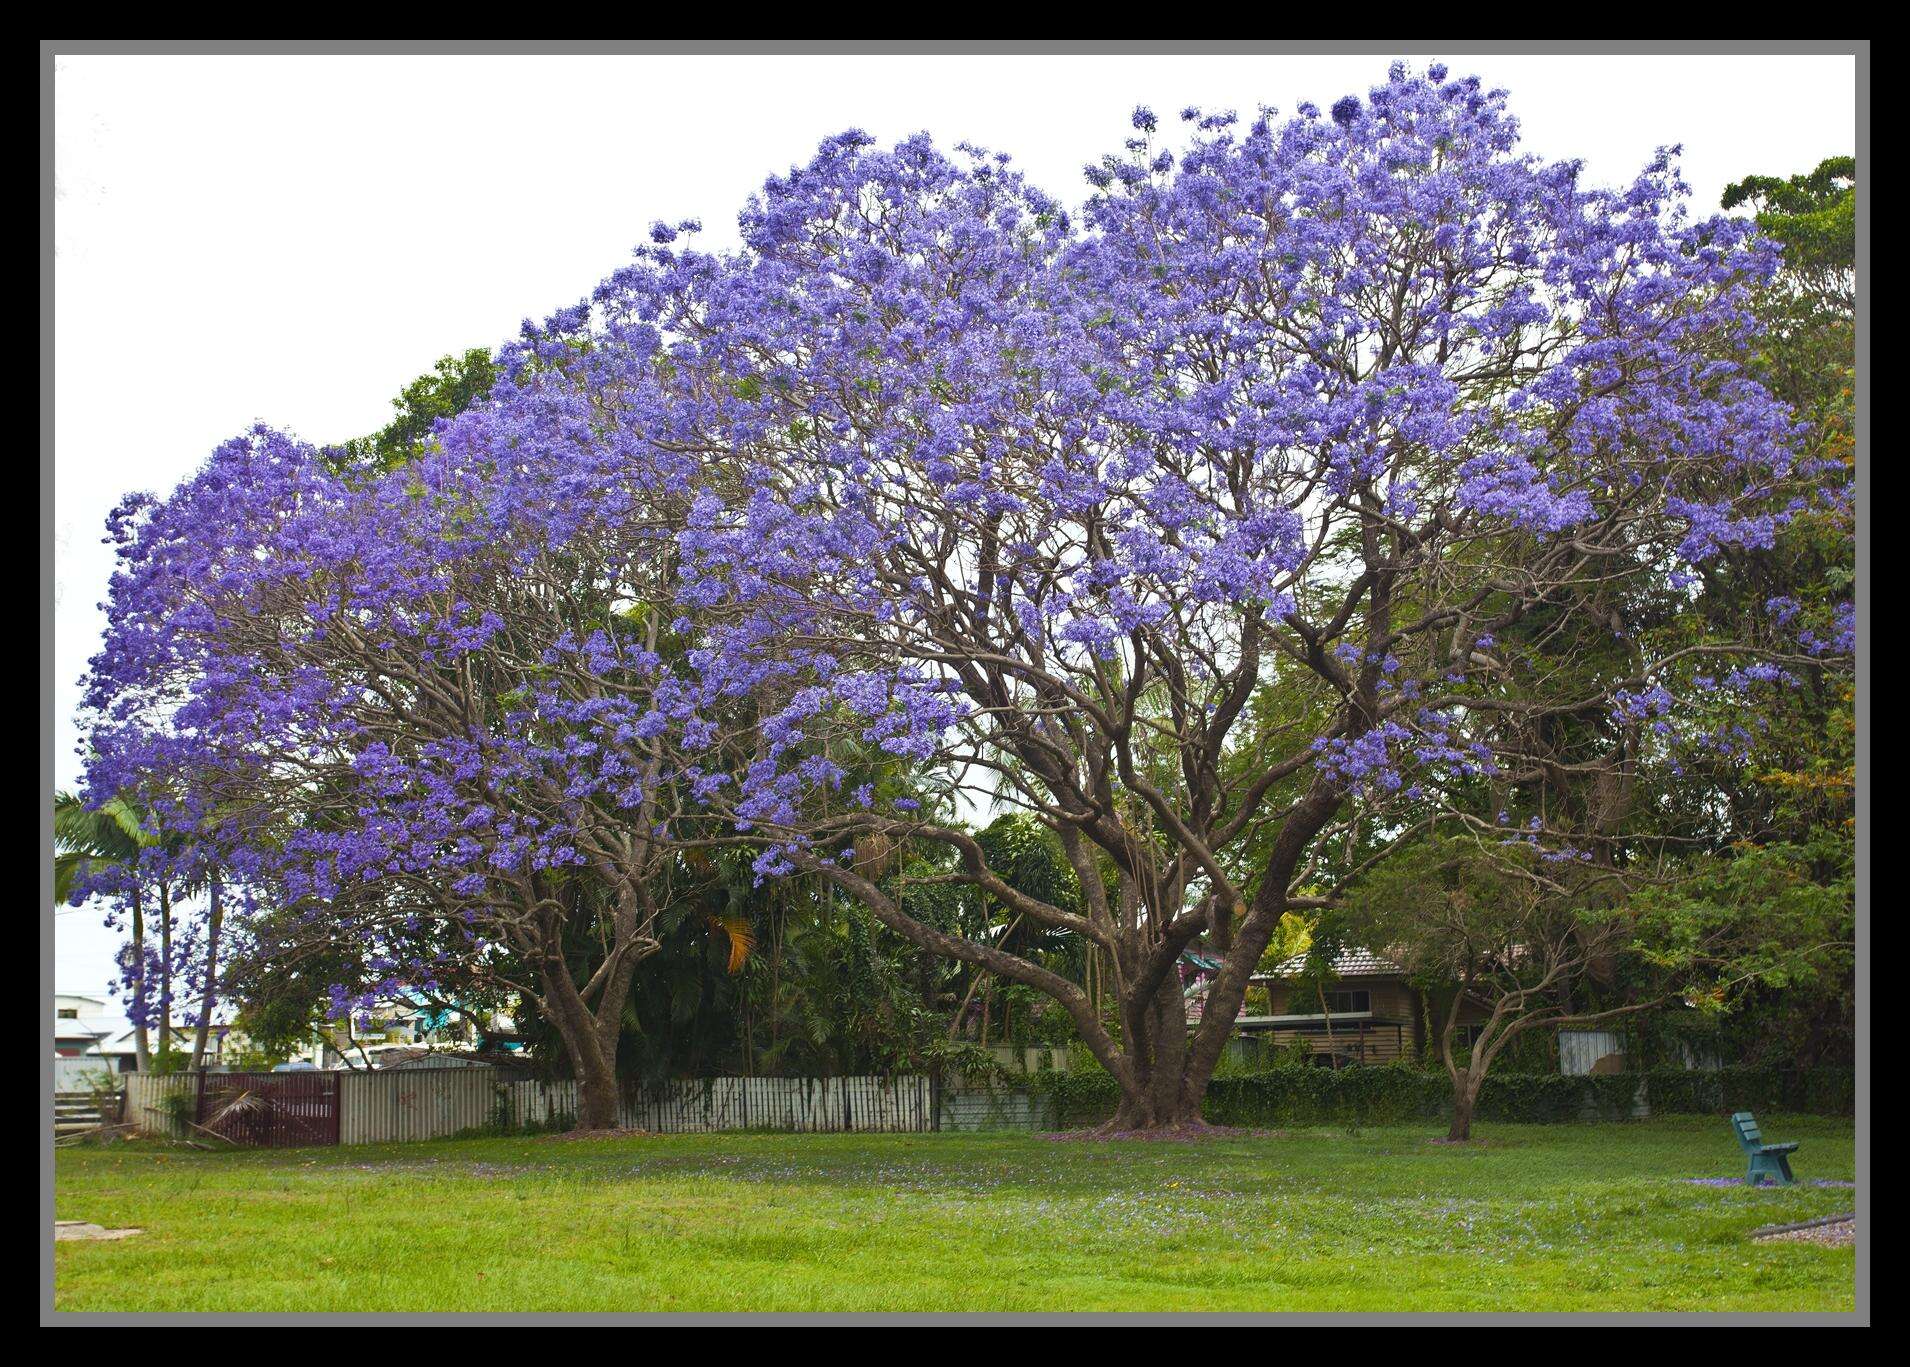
(1029, 1063), (1857, 1128)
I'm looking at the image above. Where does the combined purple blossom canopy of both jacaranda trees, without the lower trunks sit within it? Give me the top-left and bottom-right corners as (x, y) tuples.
(86, 67), (1851, 1015)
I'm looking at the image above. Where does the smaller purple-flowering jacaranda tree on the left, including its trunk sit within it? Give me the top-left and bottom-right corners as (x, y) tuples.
(90, 366), (718, 1126)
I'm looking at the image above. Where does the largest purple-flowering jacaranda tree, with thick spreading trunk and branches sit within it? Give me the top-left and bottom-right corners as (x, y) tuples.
(567, 69), (1818, 1126)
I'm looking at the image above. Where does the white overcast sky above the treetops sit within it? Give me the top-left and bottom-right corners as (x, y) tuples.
(52, 52), (1855, 995)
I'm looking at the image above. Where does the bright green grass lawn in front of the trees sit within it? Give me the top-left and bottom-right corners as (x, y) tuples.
(55, 1115), (1866, 1312)
